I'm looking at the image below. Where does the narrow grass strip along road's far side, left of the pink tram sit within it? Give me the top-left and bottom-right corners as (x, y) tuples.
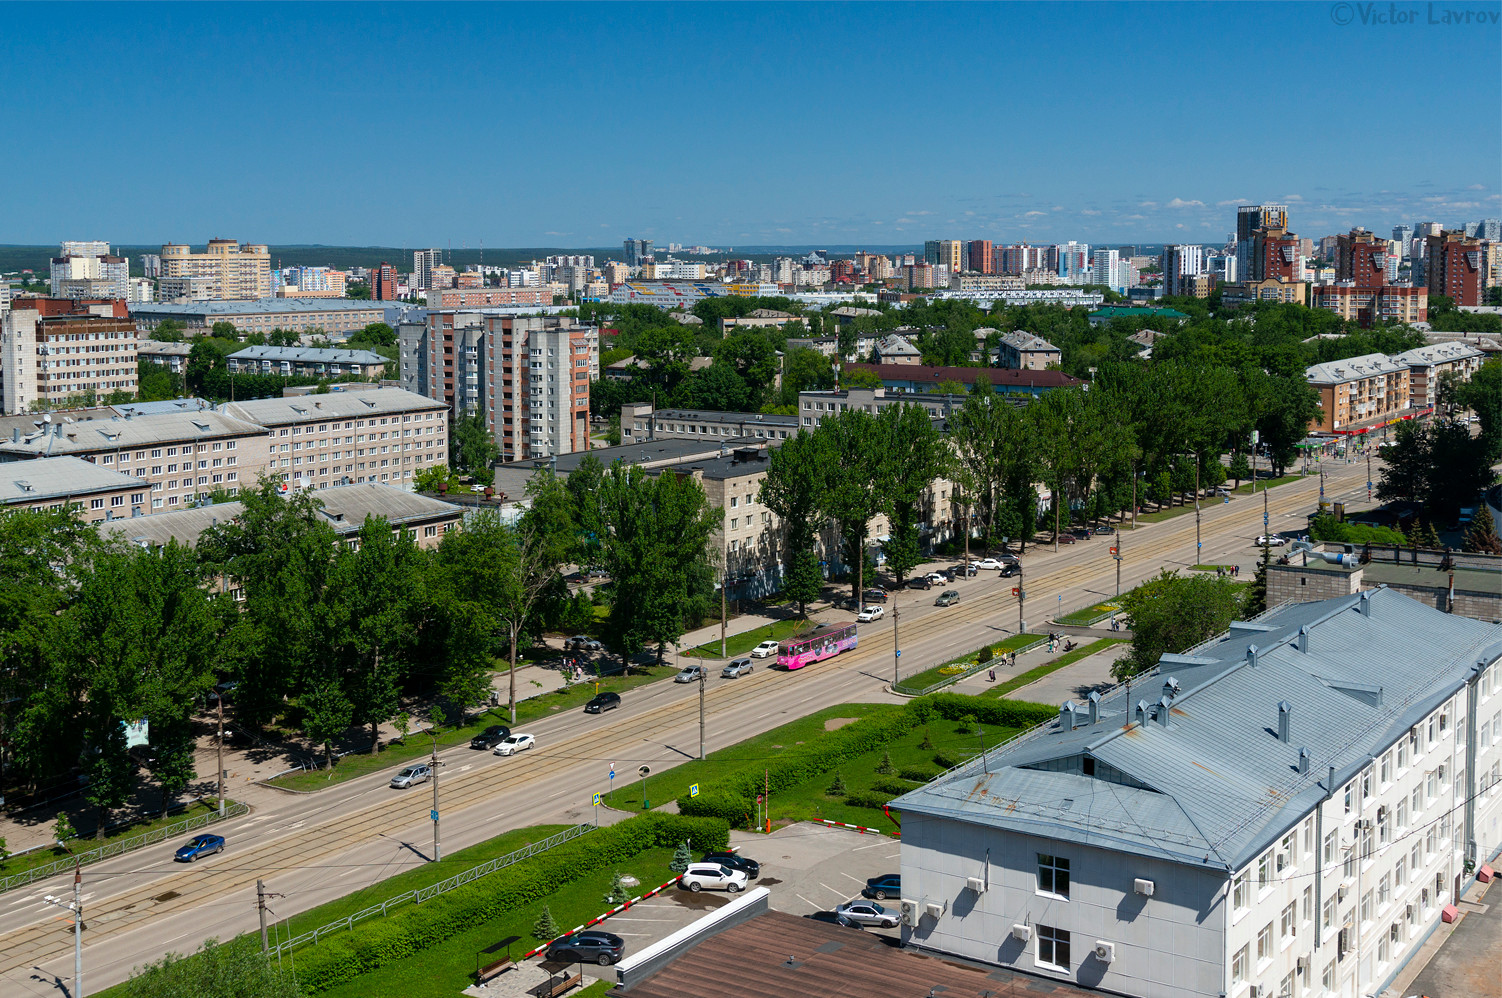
(272, 666), (677, 791)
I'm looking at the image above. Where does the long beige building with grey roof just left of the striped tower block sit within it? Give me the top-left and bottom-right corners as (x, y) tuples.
(224, 388), (449, 488)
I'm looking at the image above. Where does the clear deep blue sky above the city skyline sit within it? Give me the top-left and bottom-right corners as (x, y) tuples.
(0, 0), (1502, 246)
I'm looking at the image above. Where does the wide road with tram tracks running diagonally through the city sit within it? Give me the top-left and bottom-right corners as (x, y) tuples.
(0, 463), (1367, 996)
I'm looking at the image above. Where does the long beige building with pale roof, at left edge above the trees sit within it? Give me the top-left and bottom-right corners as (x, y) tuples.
(0, 408), (267, 516)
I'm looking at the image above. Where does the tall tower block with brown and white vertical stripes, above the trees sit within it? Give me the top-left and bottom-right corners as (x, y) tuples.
(398, 311), (599, 461)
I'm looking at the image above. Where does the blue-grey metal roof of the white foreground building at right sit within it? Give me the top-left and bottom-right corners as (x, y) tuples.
(894, 589), (1502, 870)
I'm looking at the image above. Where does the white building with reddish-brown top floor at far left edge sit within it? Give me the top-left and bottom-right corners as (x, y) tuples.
(0, 298), (138, 413)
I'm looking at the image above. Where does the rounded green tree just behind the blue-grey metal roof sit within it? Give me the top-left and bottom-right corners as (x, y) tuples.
(1111, 570), (1242, 681)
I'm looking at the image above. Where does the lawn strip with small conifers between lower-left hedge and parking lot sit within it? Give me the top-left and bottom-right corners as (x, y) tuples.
(320, 849), (673, 998)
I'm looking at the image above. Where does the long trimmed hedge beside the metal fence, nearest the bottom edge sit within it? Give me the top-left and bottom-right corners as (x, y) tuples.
(297, 813), (730, 993)
